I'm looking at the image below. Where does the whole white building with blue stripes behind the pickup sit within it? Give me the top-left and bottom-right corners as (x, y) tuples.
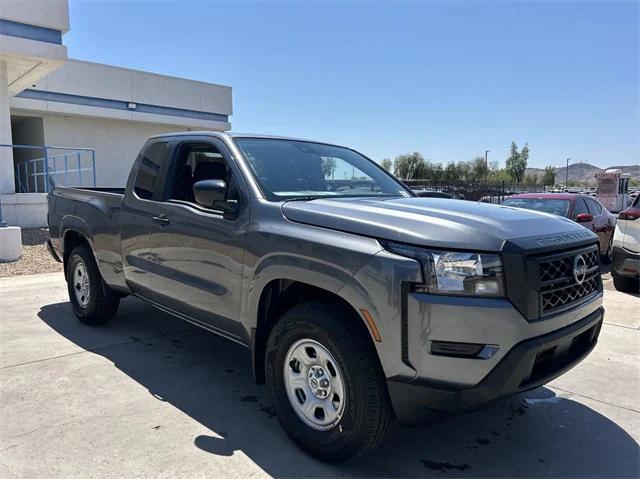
(0, 0), (232, 241)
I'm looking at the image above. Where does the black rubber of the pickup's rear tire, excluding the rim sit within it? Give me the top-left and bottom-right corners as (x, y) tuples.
(67, 245), (120, 326)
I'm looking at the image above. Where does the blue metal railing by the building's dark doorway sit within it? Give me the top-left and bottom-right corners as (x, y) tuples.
(0, 144), (96, 193)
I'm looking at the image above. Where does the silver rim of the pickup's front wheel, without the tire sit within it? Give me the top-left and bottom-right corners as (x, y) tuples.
(284, 339), (346, 431)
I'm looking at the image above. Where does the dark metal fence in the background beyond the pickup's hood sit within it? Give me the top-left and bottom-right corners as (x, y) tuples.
(404, 180), (545, 203)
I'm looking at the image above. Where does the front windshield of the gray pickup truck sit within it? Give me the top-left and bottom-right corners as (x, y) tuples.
(235, 138), (411, 201)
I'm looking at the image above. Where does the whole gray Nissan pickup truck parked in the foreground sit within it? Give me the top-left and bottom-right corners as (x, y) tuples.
(48, 132), (603, 461)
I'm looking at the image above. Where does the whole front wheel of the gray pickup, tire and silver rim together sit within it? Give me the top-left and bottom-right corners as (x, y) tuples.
(265, 303), (394, 462)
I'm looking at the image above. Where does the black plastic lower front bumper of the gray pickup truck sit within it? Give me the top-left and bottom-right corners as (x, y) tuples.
(387, 307), (604, 423)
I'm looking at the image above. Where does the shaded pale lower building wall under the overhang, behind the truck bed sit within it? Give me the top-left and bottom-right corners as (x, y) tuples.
(44, 115), (192, 187)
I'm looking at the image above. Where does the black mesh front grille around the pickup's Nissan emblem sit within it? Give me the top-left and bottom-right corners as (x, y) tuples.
(537, 246), (602, 316)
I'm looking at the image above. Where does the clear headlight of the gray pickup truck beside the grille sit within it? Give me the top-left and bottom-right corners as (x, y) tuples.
(381, 241), (504, 297)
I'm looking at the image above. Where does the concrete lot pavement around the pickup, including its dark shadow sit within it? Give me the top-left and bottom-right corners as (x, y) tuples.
(0, 273), (640, 478)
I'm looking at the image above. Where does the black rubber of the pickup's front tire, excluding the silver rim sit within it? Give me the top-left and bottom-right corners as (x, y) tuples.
(265, 303), (395, 462)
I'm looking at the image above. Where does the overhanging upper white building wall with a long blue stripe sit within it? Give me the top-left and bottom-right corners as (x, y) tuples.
(11, 59), (233, 131)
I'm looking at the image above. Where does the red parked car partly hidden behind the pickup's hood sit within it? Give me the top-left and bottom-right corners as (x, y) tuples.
(502, 193), (616, 263)
